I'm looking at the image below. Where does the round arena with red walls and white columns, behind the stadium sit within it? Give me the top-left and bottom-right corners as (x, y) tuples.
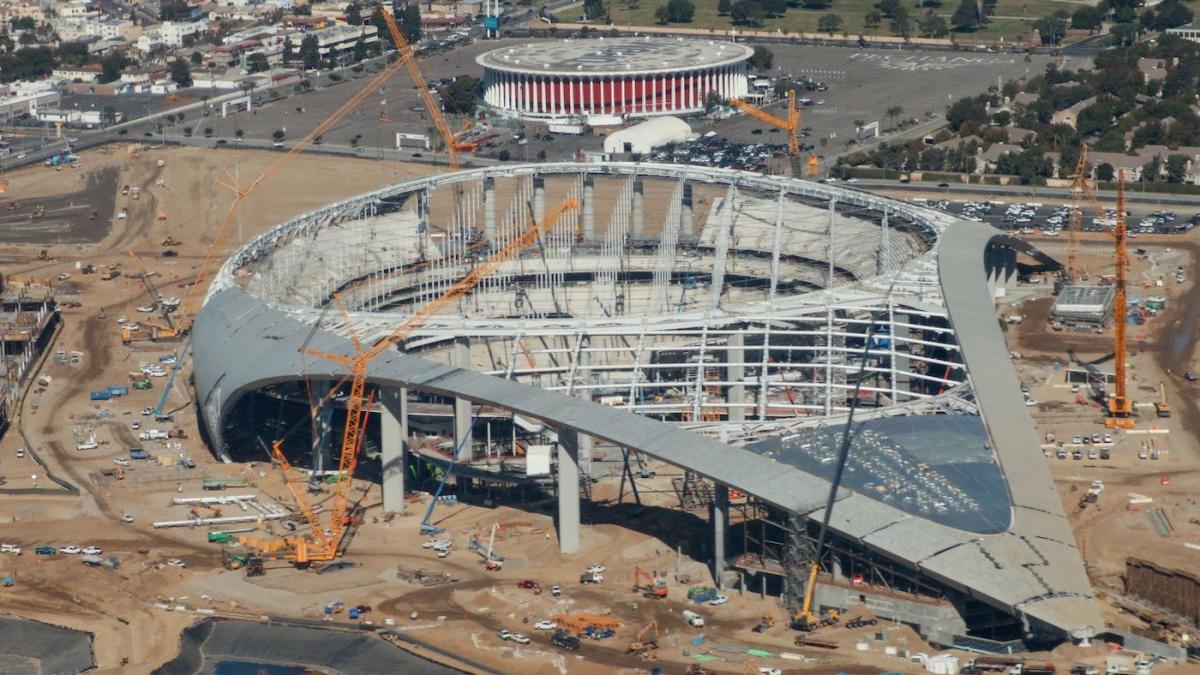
(476, 36), (754, 118)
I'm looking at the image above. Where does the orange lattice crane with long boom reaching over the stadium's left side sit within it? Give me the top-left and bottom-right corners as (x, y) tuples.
(262, 199), (578, 562)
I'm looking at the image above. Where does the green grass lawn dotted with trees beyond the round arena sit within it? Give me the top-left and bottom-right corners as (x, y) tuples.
(557, 0), (1082, 42)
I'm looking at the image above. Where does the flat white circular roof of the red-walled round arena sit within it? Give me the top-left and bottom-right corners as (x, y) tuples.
(475, 36), (754, 74)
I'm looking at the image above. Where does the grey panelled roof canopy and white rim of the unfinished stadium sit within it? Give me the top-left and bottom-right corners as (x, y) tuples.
(193, 163), (1103, 638)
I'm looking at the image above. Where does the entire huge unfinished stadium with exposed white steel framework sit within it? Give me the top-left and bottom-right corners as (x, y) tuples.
(193, 163), (1103, 650)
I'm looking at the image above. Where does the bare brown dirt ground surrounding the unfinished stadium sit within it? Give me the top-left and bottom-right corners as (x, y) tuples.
(0, 145), (1200, 675)
